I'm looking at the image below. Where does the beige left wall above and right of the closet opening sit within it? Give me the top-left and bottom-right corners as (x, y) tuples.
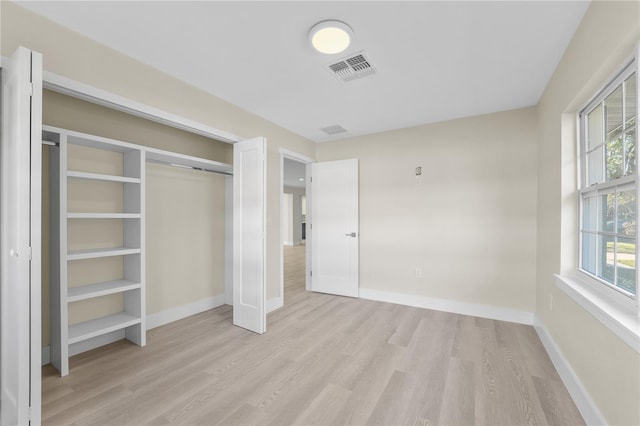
(0, 1), (315, 298)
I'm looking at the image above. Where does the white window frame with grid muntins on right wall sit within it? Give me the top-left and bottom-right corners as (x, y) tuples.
(577, 57), (640, 302)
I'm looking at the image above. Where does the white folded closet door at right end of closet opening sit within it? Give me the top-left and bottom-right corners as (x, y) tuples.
(233, 138), (267, 334)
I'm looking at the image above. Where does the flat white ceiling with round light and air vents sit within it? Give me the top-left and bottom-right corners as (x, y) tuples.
(18, 1), (589, 142)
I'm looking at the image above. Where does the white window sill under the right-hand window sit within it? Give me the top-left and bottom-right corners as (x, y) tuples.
(556, 274), (640, 353)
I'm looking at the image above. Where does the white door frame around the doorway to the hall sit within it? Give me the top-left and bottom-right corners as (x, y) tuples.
(278, 148), (316, 313)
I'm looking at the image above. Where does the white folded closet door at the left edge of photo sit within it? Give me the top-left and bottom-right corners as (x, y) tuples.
(0, 48), (42, 425)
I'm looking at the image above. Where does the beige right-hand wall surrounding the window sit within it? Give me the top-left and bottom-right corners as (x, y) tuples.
(536, 1), (640, 424)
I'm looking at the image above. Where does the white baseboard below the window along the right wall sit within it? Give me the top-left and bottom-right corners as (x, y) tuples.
(534, 316), (607, 425)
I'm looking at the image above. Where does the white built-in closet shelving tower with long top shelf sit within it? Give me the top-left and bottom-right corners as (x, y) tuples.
(43, 126), (232, 376)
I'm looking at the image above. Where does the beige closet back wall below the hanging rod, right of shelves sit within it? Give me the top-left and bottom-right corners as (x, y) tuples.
(146, 163), (225, 314)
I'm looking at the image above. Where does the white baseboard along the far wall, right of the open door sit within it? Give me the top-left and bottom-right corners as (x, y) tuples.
(360, 288), (533, 325)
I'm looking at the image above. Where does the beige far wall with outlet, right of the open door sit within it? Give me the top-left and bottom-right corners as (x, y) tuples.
(316, 108), (537, 312)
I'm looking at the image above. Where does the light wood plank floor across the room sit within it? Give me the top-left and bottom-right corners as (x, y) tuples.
(42, 247), (584, 425)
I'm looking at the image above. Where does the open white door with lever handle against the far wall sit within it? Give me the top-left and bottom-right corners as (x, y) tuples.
(307, 159), (360, 297)
